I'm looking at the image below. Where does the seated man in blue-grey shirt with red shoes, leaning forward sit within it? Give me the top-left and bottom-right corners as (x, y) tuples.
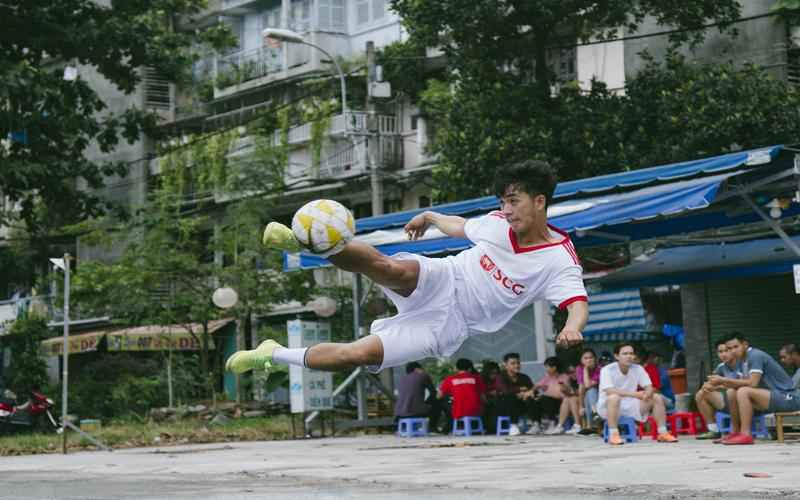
(708, 332), (800, 445)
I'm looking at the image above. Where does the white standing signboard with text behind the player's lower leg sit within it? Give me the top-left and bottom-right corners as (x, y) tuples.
(286, 320), (333, 413)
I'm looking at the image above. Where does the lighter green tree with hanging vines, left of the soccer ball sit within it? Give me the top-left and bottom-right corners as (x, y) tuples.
(72, 124), (313, 393)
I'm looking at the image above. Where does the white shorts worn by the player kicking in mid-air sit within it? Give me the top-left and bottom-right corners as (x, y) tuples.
(369, 252), (467, 372)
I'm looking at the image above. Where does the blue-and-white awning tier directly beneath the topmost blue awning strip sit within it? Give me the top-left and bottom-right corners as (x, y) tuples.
(284, 171), (741, 270)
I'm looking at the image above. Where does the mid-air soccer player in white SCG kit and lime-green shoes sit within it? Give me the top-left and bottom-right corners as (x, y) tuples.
(226, 160), (589, 373)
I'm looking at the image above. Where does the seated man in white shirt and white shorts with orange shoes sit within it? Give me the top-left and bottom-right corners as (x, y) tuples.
(597, 342), (677, 445)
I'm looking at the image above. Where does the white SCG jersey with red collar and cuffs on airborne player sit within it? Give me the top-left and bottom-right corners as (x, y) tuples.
(448, 211), (587, 332)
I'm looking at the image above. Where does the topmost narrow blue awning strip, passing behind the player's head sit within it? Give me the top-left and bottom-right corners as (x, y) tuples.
(356, 146), (783, 233)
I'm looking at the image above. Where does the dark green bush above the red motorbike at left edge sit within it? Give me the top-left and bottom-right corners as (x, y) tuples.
(3, 315), (48, 397)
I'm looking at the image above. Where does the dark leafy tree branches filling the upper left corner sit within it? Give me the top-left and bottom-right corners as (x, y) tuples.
(0, 0), (230, 232)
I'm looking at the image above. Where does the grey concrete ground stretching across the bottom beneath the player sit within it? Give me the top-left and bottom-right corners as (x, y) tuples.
(0, 435), (800, 500)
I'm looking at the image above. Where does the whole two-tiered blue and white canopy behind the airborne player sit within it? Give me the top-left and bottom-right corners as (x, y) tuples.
(284, 146), (788, 270)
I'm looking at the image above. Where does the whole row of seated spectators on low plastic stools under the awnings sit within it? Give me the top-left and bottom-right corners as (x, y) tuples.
(395, 333), (800, 444)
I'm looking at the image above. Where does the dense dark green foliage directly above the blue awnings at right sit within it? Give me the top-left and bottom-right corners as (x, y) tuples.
(422, 53), (800, 198)
